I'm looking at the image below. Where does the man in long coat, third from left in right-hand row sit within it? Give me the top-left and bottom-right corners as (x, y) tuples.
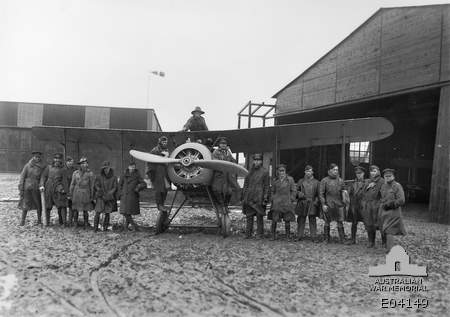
(295, 165), (320, 241)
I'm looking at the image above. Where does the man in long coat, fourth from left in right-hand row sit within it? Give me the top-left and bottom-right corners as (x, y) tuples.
(319, 163), (346, 243)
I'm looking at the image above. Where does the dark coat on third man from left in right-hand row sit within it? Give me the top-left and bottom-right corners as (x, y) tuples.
(295, 177), (320, 216)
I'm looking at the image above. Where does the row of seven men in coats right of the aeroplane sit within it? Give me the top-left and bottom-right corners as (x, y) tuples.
(242, 154), (406, 250)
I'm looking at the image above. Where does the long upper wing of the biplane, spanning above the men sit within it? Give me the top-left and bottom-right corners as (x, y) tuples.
(33, 117), (394, 153)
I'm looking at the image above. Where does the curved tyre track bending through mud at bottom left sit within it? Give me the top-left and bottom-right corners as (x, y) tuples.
(89, 238), (148, 317)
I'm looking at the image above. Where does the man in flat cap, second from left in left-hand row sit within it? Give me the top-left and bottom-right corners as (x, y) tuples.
(40, 153), (69, 226)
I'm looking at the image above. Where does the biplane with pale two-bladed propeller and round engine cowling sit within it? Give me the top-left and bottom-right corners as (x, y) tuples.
(33, 117), (394, 236)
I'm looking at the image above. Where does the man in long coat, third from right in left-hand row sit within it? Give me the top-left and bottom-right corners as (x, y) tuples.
(70, 157), (95, 229)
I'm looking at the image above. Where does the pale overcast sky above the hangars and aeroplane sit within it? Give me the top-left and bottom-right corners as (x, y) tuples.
(0, 0), (448, 131)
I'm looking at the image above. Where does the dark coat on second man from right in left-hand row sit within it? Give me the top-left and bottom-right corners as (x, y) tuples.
(94, 168), (119, 213)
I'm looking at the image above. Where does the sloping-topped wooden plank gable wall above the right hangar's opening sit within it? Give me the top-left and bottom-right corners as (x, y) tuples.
(277, 5), (450, 113)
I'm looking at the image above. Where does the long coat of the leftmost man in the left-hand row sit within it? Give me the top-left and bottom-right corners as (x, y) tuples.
(18, 160), (44, 210)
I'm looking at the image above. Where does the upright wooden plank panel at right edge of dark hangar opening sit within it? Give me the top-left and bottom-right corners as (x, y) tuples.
(429, 86), (450, 223)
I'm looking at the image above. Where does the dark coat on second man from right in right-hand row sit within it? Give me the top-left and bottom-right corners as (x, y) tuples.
(361, 175), (384, 228)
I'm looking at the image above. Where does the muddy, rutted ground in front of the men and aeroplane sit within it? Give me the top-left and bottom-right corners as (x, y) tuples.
(0, 175), (450, 316)
